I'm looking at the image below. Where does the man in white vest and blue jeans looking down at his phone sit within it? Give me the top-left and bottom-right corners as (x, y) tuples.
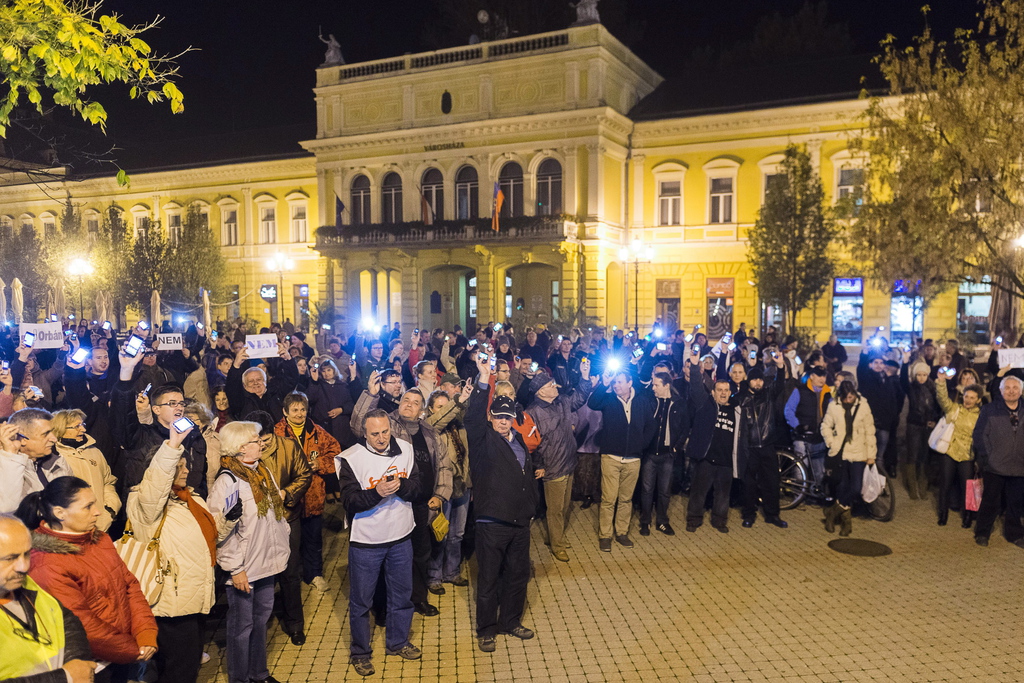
(335, 410), (422, 676)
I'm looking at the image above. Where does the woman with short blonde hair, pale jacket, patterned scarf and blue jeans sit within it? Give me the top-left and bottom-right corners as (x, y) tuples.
(207, 421), (289, 683)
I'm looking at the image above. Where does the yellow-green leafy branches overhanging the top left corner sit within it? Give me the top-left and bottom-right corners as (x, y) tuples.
(0, 0), (183, 137)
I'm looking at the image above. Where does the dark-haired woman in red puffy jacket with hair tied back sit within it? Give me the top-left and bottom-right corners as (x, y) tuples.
(17, 476), (157, 682)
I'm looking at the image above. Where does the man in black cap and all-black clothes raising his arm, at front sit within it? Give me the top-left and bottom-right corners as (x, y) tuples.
(464, 358), (544, 652)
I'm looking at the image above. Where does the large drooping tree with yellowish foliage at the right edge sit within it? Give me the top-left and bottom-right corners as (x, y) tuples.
(850, 0), (1024, 313)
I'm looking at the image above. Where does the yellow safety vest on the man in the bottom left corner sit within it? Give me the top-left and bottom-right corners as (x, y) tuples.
(0, 577), (65, 680)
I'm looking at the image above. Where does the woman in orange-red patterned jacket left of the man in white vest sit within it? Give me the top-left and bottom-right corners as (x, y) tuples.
(273, 391), (341, 591)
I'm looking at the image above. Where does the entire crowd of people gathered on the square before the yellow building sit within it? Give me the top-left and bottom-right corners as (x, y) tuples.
(0, 321), (1024, 683)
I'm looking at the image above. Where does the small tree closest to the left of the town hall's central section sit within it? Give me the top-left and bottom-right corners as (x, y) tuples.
(162, 204), (224, 305)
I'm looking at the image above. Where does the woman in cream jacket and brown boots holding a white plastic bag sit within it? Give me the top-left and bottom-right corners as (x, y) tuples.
(821, 381), (878, 536)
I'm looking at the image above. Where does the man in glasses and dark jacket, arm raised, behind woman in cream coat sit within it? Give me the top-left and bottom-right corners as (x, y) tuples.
(111, 350), (207, 499)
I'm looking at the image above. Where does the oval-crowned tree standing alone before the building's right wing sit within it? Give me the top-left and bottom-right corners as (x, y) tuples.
(746, 145), (839, 330)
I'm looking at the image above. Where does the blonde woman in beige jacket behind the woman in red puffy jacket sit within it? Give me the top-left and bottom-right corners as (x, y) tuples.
(51, 410), (121, 531)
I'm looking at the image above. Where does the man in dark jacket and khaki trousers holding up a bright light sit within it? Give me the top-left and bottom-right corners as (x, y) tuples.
(587, 369), (657, 553)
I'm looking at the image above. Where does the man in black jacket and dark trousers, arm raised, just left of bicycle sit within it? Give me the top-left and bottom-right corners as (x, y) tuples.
(736, 360), (788, 528)
